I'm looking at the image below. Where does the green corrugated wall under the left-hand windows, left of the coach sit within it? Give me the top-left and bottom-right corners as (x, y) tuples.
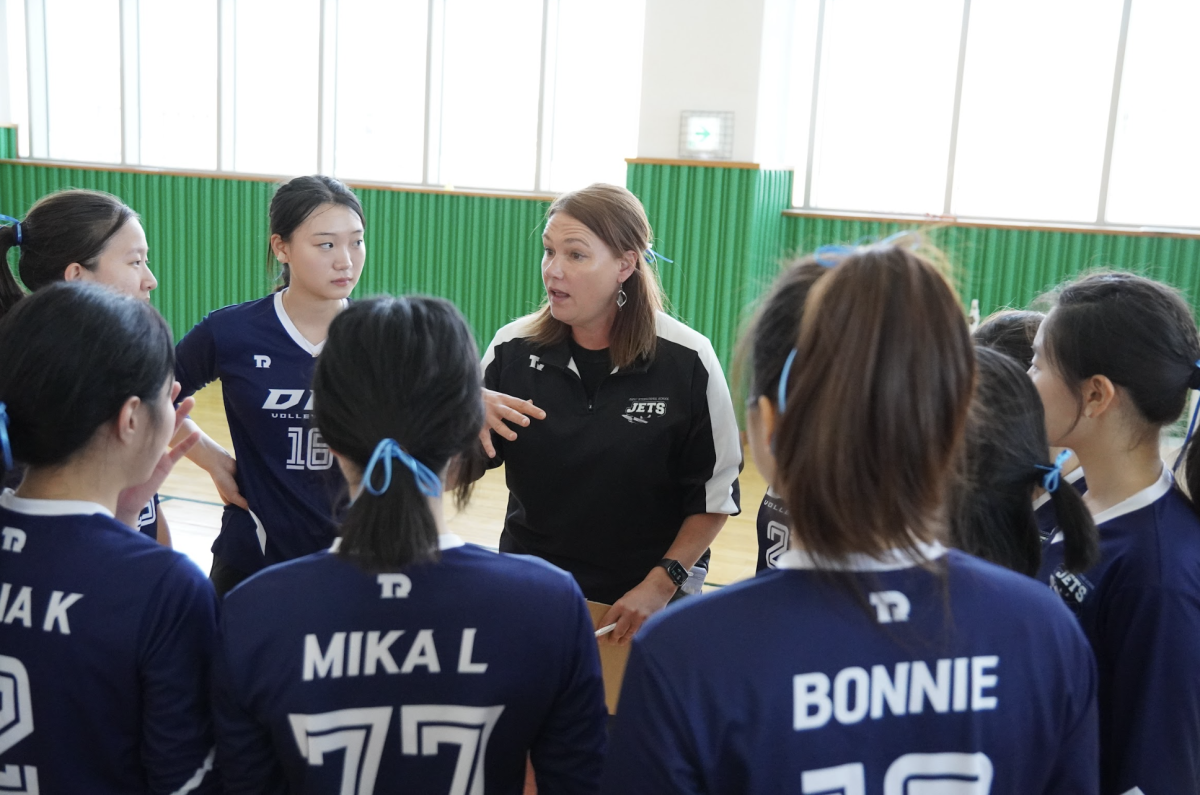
(0, 163), (546, 346)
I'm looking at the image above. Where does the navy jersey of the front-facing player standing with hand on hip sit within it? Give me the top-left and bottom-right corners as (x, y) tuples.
(175, 293), (346, 574)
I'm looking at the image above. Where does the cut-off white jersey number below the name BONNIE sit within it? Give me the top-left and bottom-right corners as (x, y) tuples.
(800, 753), (992, 795)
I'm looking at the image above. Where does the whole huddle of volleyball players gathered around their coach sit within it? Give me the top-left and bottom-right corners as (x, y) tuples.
(0, 177), (1200, 795)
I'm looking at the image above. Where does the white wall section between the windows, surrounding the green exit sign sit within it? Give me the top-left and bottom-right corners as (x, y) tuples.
(637, 0), (763, 161)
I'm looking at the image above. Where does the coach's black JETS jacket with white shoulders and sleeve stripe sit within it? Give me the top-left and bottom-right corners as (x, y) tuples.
(484, 312), (742, 604)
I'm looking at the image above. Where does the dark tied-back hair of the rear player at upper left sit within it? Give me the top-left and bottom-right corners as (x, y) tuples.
(0, 189), (138, 317)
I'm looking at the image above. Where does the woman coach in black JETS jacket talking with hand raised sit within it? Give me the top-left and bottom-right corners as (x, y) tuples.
(481, 185), (742, 642)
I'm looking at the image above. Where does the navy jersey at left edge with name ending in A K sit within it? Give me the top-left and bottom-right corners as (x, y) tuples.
(0, 491), (217, 795)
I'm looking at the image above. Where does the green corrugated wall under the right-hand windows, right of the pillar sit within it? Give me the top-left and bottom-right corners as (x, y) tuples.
(784, 216), (1200, 316)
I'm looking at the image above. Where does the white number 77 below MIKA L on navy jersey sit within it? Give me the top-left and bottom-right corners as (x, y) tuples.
(288, 704), (504, 795)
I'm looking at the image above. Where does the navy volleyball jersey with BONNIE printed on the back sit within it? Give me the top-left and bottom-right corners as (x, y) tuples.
(601, 546), (1099, 795)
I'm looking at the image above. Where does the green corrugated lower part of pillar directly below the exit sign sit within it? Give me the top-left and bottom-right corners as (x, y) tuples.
(625, 162), (791, 366)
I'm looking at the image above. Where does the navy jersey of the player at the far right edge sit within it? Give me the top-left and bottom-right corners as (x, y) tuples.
(1038, 466), (1200, 795)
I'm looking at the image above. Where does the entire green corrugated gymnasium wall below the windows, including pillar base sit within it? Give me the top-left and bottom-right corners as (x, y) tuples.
(0, 158), (1200, 377)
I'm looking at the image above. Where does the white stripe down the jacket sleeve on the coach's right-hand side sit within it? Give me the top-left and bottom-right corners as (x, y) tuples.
(655, 312), (742, 514)
